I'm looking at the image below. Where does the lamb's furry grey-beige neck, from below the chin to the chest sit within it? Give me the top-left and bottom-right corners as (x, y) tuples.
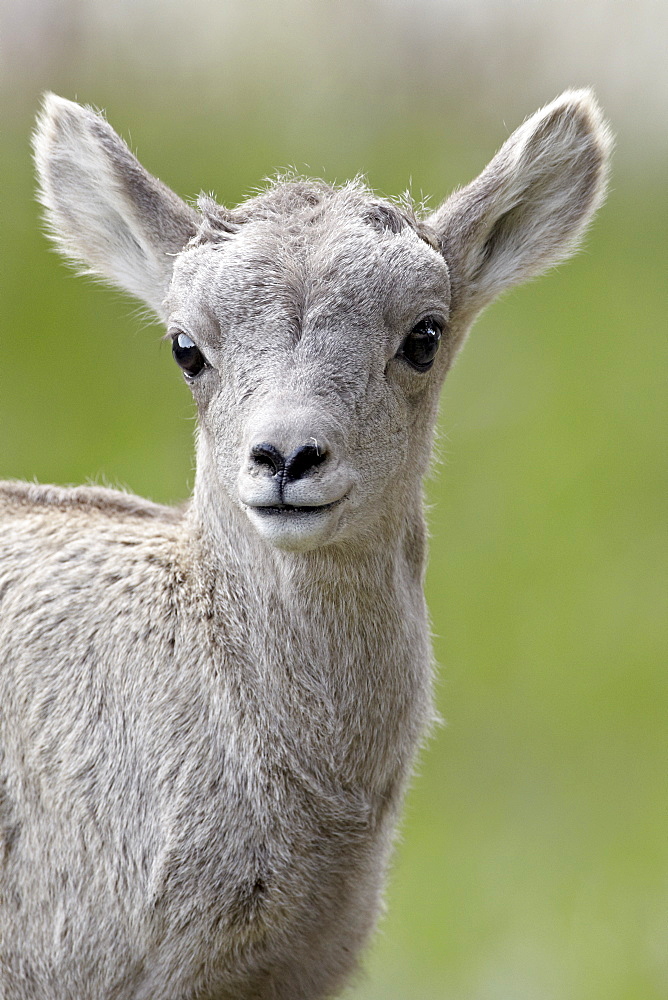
(190, 456), (431, 793)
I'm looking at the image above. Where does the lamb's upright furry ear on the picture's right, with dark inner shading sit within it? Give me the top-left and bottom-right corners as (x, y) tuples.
(428, 90), (612, 322)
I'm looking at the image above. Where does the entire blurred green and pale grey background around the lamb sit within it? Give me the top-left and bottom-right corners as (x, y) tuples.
(0, 0), (668, 1000)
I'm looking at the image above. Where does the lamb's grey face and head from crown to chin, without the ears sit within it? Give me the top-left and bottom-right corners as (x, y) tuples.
(167, 184), (451, 548)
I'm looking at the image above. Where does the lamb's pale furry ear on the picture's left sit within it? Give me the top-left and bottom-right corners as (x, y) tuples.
(33, 94), (199, 316)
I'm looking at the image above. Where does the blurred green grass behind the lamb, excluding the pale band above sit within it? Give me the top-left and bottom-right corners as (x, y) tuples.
(0, 108), (668, 1000)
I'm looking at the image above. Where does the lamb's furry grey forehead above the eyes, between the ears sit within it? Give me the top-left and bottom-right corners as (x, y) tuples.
(170, 188), (449, 320)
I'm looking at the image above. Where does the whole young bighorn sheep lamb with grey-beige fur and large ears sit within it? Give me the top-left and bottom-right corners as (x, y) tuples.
(0, 91), (610, 1000)
